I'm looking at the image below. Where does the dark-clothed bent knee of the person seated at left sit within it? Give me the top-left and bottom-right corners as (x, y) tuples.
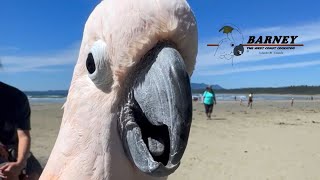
(24, 155), (43, 180)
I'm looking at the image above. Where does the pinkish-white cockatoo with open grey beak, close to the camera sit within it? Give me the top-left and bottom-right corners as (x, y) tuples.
(40, 0), (198, 180)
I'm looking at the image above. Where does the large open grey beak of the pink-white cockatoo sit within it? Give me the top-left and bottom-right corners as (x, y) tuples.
(119, 42), (192, 176)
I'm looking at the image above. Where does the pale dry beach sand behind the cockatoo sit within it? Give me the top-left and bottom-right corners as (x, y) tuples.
(28, 101), (320, 180)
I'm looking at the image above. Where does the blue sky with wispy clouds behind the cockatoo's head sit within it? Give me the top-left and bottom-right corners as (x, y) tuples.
(0, 0), (320, 90)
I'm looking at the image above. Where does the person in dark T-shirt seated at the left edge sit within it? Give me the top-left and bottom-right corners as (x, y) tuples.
(0, 81), (42, 180)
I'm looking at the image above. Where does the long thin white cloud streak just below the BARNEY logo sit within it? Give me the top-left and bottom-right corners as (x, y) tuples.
(198, 60), (320, 76)
